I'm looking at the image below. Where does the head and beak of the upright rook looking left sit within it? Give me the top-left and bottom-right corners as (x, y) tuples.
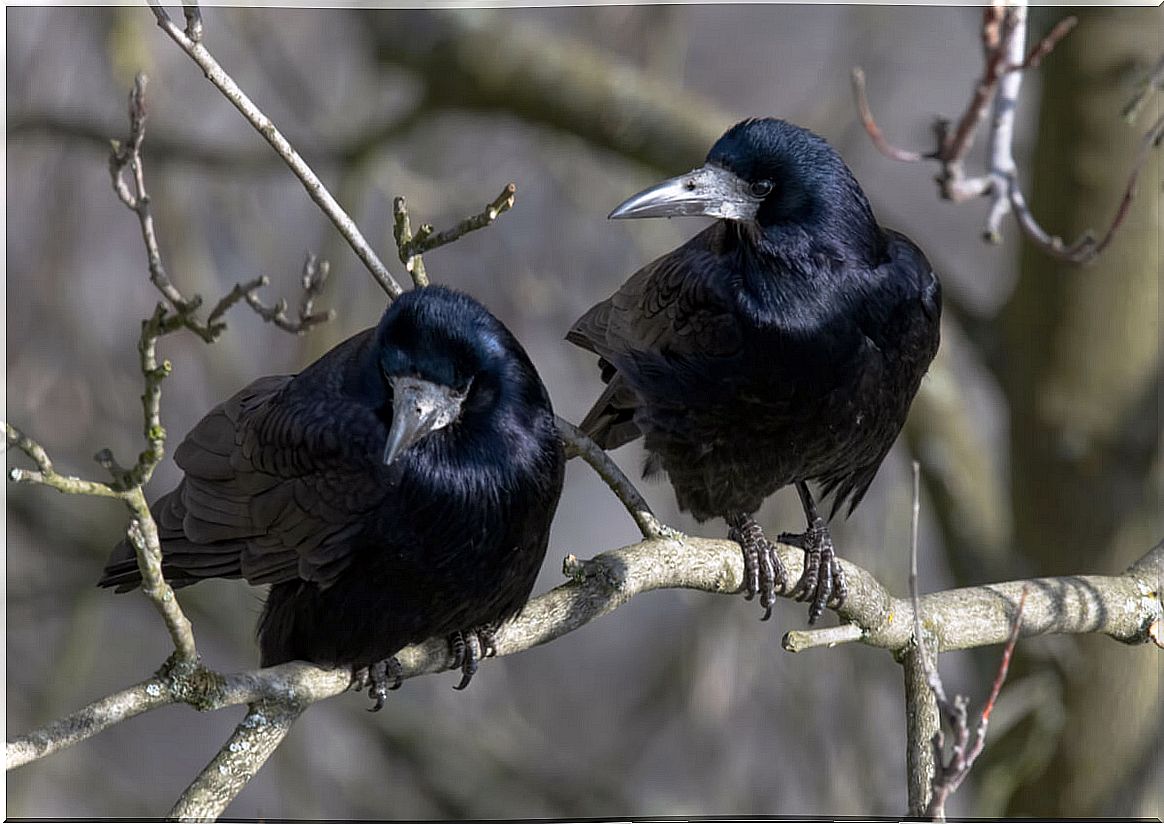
(610, 118), (872, 240)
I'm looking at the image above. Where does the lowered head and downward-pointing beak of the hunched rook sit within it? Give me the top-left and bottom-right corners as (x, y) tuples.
(376, 286), (540, 464)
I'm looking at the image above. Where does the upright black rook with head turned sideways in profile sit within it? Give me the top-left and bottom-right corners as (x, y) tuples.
(567, 118), (941, 624)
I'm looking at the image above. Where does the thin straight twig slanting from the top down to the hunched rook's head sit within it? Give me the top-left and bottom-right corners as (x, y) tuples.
(149, 0), (404, 298)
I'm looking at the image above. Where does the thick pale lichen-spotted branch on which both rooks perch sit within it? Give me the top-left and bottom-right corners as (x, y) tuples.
(8, 534), (1164, 768)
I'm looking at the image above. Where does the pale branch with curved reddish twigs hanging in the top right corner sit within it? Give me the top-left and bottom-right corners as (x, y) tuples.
(852, 2), (1164, 264)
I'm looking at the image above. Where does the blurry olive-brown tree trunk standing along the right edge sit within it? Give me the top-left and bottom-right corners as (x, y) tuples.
(975, 8), (1164, 817)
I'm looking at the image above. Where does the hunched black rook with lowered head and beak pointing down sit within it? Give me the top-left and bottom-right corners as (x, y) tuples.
(100, 286), (566, 709)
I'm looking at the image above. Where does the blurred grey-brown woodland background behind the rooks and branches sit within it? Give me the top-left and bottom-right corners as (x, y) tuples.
(5, 5), (1164, 818)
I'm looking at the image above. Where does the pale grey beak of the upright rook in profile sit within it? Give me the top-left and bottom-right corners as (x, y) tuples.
(610, 165), (761, 220)
